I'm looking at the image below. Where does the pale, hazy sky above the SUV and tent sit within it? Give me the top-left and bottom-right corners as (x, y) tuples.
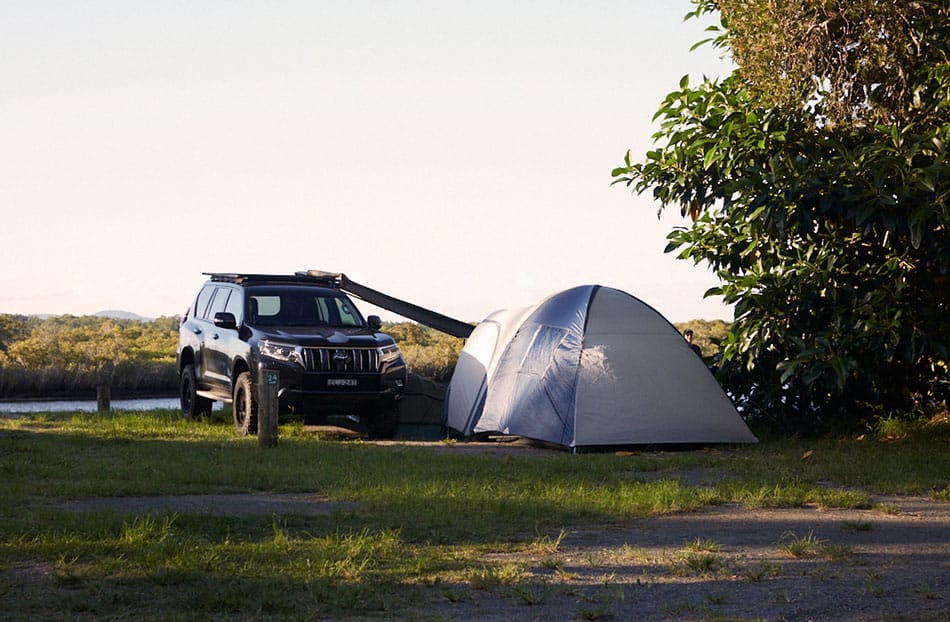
(0, 0), (732, 322)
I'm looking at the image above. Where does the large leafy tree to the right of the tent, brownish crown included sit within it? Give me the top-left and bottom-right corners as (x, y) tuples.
(613, 0), (950, 432)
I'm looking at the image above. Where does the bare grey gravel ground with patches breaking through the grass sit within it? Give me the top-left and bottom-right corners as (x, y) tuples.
(59, 442), (950, 622)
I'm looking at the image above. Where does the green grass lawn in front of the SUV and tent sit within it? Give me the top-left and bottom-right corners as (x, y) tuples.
(0, 412), (950, 620)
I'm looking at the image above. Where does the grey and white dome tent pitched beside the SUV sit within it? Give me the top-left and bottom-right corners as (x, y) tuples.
(444, 285), (756, 448)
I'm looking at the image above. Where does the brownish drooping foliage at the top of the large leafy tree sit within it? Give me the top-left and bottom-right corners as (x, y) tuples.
(708, 0), (950, 125)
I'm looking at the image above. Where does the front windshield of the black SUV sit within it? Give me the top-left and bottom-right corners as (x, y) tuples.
(245, 286), (365, 328)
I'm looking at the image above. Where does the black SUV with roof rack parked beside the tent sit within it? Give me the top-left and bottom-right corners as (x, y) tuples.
(177, 273), (408, 438)
